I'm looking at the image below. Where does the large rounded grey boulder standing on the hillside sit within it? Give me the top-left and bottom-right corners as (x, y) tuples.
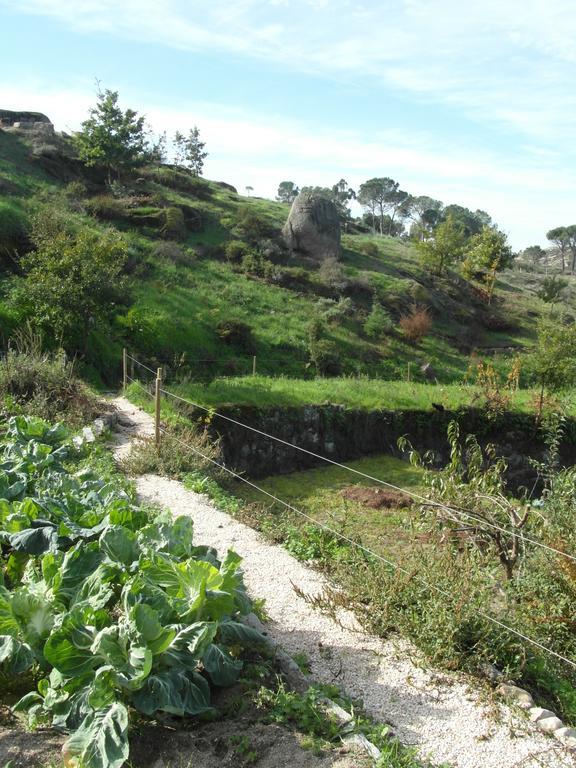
(282, 192), (340, 261)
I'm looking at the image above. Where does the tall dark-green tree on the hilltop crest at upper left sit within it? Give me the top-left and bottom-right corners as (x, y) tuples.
(74, 89), (150, 184)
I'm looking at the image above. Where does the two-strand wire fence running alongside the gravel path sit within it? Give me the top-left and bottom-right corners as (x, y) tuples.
(122, 354), (576, 669)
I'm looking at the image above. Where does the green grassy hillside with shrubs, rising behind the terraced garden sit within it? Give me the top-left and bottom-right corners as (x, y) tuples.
(0, 126), (576, 392)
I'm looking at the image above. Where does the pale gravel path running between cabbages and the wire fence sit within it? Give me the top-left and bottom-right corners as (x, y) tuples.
(114, 398), (576, 768)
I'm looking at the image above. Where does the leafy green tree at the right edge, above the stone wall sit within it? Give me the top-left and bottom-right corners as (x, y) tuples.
(530, 317), (576, 417)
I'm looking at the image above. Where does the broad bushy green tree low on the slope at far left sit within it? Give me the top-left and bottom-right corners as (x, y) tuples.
(22, 219), (128, 356)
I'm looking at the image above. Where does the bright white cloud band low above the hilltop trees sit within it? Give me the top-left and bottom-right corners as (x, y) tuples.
(0, 82), (576, 248)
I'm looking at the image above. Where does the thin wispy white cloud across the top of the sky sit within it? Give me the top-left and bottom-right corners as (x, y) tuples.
(6, 0), (576, 140)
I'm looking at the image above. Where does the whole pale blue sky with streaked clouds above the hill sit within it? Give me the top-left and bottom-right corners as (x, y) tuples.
(0, 0), (576, 249)
